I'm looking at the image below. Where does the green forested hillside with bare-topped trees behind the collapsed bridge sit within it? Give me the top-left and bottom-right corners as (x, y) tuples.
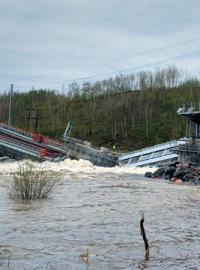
(0, 67), (200, 150)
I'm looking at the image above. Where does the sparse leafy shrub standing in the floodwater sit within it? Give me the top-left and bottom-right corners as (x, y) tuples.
(8, 161), (57, 200)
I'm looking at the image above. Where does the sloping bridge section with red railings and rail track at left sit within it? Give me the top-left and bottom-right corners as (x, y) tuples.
(0, 123), (66, 161)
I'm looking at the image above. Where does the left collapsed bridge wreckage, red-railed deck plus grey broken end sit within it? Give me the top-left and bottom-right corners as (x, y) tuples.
(0, 123), (118, 167)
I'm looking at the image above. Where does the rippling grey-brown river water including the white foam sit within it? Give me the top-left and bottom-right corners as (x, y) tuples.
(0, 160), (200, 270)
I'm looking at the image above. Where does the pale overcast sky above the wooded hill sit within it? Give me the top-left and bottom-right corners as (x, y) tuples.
(0, 0), (200, 91)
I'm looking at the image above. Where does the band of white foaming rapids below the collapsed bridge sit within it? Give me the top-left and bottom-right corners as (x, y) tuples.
(0, 159), (156, 175)
